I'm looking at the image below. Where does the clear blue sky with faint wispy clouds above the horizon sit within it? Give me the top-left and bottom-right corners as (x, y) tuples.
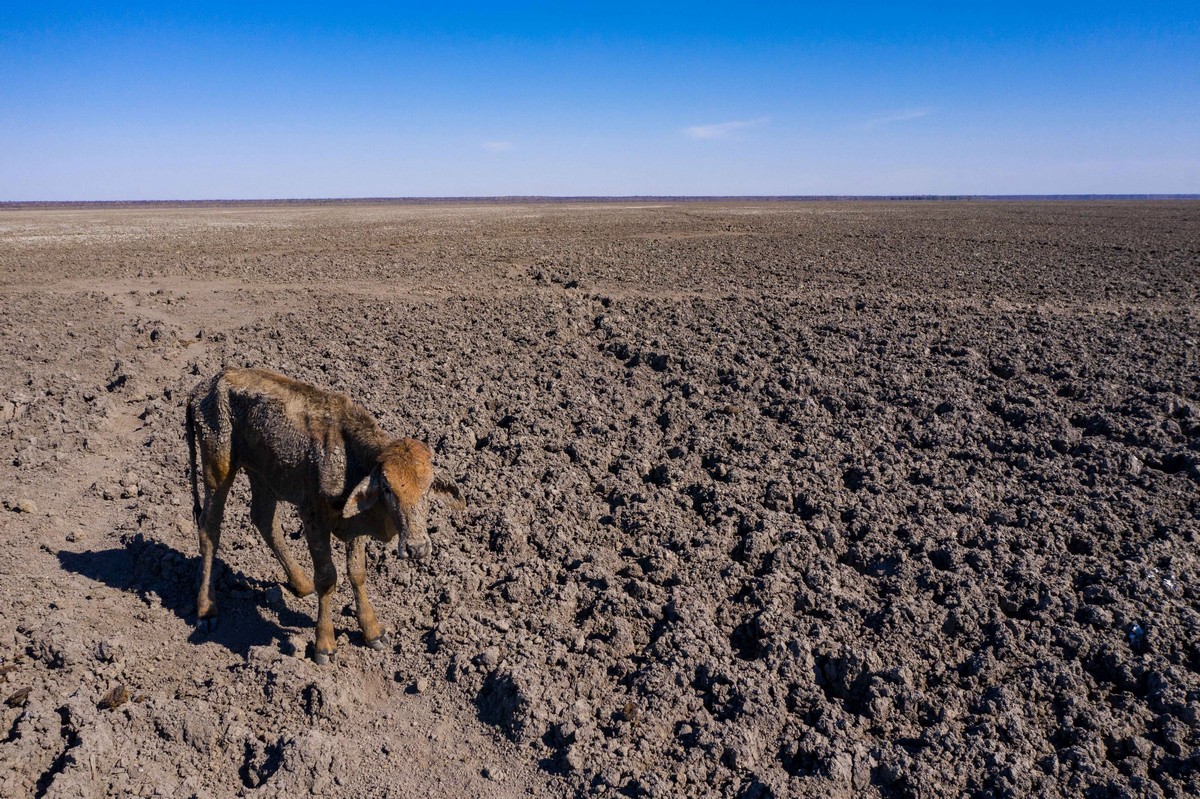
(0, 0), (1200, 200)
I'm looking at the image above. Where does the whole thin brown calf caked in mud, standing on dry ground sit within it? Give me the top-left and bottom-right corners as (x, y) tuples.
(186, 368), (461, 662)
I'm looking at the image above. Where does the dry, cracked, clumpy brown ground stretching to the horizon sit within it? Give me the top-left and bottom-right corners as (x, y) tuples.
(0, 202), (1200, 798)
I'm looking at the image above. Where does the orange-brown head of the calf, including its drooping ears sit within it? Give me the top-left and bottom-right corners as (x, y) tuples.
(342, 438), (462, 558)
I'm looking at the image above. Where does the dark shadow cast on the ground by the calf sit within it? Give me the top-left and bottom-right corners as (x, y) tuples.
(58, 533), (314, 656)
